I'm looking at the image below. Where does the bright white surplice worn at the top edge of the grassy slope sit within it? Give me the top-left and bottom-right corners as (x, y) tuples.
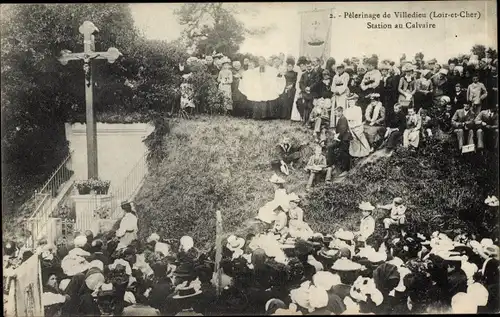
(238, 66), (285, 101)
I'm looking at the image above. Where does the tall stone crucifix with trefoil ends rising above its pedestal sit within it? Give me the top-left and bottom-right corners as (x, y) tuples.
(59, 21), (122, 179)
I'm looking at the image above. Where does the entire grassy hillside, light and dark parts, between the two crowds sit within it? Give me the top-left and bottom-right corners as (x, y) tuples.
(136, 117), (498, 248)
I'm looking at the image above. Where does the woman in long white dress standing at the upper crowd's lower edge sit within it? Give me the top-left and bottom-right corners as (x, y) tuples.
(345, 94), (370, 158)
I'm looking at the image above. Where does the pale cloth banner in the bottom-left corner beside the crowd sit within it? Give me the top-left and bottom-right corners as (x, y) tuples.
(7, 254), (44, 317)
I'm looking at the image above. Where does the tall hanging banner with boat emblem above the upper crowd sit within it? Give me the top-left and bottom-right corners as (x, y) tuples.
(300, 10), (332, 61)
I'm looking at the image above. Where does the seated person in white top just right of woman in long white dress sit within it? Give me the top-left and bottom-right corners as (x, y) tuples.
(365, 94), (385, 147)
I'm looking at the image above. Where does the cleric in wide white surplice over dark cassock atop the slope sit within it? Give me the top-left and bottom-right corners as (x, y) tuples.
(240, 56), (285, 119)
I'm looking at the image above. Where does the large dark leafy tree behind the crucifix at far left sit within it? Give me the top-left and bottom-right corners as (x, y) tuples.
(0, 3), (137, 215)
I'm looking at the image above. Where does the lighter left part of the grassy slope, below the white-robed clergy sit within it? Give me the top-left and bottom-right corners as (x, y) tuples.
(136, 117), (312, 246)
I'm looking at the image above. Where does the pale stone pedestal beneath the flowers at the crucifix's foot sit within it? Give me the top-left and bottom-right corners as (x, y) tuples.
(71, 195), (113, 236)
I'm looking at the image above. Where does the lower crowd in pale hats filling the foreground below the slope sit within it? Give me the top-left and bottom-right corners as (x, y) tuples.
(4, 189), (500, 317)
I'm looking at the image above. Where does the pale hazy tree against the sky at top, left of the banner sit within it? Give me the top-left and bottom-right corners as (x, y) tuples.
(175, 3), (273, 57)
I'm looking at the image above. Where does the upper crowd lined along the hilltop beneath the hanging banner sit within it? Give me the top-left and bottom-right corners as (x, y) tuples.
(182, 53), (498, 188)
